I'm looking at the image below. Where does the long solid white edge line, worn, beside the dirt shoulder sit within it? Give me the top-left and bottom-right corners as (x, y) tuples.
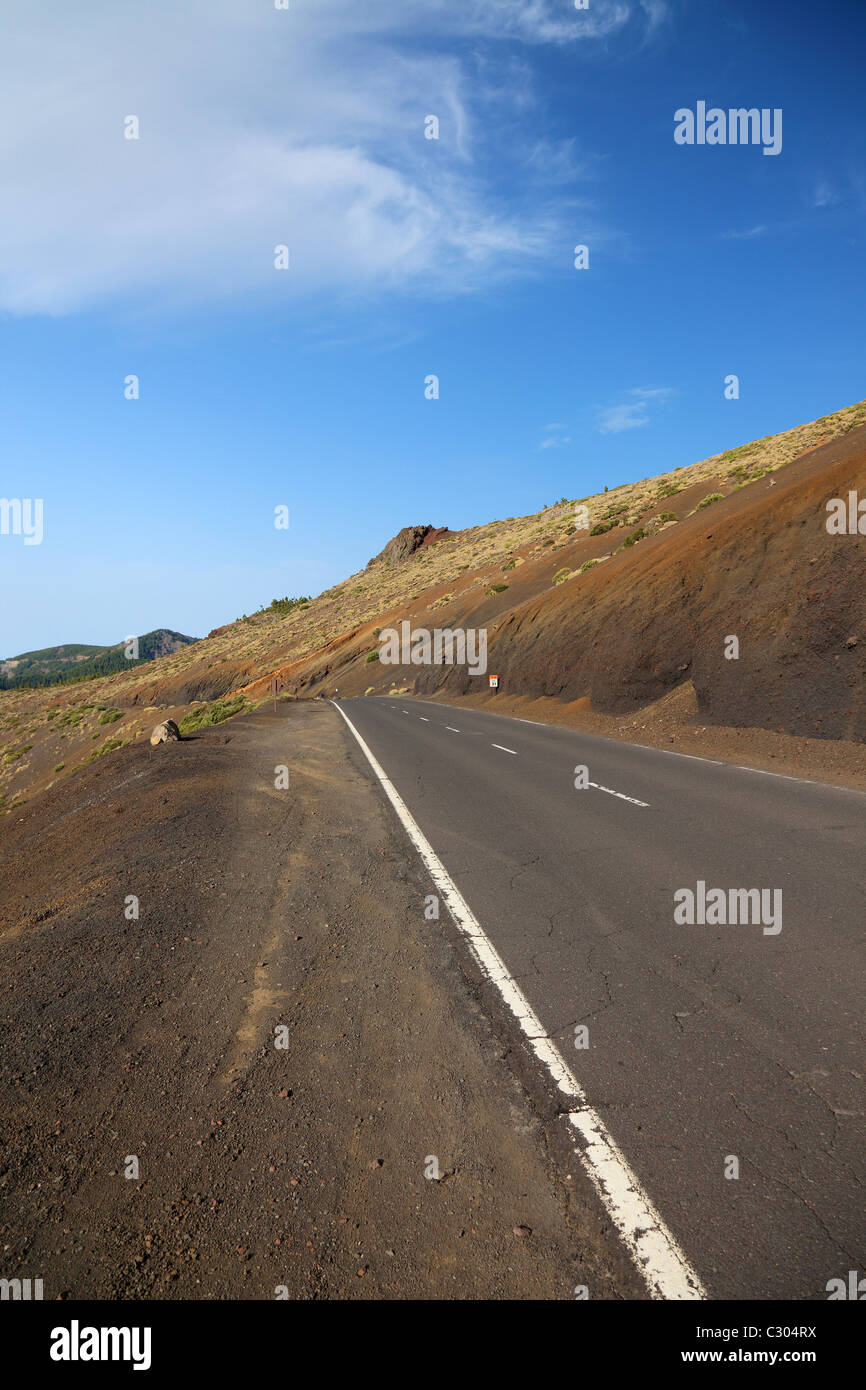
(331, 701), (706, 1298)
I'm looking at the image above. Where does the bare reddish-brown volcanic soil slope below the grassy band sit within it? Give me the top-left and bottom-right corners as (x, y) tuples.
(293, 427), (866, 776)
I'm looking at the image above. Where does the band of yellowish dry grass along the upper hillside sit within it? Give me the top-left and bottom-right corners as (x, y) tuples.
(0, 391), (866, 810)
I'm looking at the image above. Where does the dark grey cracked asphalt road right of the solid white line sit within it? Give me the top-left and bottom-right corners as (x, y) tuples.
(339, 696), (866, 1300)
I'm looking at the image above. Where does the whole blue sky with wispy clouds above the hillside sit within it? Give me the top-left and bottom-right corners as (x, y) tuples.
(0, 0), (866, 656)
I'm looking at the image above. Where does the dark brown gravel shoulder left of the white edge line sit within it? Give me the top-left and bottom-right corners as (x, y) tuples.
(0, 703), (642, 1300)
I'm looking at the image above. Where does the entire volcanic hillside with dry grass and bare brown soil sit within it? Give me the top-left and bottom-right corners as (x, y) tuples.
(0, 402), (866, 810)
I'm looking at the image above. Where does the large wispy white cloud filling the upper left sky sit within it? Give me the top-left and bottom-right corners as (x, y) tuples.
(0, 0), (663, 314)
